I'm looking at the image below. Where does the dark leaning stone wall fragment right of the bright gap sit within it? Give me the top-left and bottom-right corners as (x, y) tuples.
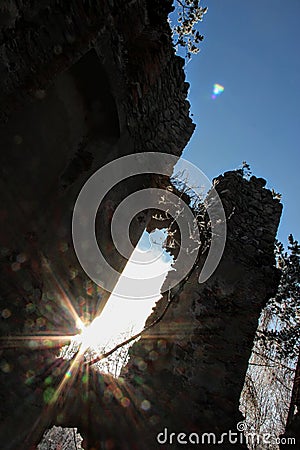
(123, 171), (282, 448)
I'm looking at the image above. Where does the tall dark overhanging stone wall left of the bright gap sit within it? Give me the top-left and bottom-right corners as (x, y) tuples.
(0, 0), (194, 450)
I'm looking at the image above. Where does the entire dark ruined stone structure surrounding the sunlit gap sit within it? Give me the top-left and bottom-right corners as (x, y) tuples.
(0, 0), (281, 450)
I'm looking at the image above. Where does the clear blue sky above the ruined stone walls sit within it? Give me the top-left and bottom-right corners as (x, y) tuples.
(177, 0), (300, 244)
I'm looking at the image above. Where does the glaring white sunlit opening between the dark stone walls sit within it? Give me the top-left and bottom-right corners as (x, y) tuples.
(64, 230), (173, 375)
